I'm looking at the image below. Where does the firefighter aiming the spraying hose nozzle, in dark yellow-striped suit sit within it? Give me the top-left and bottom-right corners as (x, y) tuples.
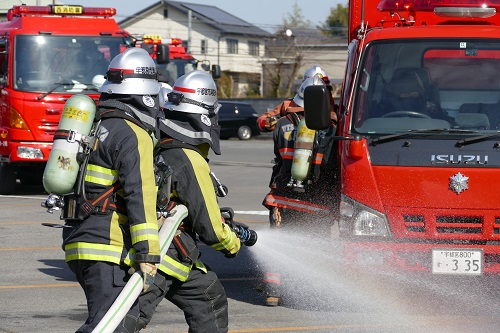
(135, 70), (241, 333)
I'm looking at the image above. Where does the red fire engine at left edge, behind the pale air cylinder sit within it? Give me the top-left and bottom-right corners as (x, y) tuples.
(0, 5), (139, 194)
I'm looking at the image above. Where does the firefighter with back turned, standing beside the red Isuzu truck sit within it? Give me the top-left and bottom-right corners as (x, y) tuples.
(263, 75), (337, 306)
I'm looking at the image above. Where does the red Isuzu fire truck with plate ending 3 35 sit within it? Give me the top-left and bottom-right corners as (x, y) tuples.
(305, 0), (500, 275)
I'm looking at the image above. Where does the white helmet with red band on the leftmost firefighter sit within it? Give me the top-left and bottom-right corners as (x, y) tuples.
(99, 48), (161, 95)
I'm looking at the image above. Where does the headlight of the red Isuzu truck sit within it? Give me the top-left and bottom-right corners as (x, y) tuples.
(339, 196), (391, 237)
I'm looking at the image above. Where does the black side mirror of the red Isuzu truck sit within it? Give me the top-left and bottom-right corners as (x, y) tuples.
(304, 85), (332, 130)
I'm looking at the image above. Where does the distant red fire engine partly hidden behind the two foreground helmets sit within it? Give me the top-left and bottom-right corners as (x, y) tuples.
(135, 34), (221, 86)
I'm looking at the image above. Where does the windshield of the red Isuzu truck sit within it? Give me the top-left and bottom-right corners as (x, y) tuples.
(351, 38), (500, 136)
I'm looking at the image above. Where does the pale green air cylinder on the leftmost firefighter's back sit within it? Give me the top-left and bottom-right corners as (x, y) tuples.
(43, 94), (97, 195)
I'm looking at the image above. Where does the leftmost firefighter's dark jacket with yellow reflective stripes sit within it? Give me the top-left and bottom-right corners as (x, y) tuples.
(63, 118), (160, 264)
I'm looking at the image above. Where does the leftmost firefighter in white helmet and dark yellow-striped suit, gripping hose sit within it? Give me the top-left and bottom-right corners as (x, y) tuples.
(63, 48), (161, 333)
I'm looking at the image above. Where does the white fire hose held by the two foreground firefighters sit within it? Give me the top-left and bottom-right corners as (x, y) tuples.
(92, 205), (188, 333)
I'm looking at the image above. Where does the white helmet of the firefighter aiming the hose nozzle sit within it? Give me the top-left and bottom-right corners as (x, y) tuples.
(163, 70), (220, 115)
